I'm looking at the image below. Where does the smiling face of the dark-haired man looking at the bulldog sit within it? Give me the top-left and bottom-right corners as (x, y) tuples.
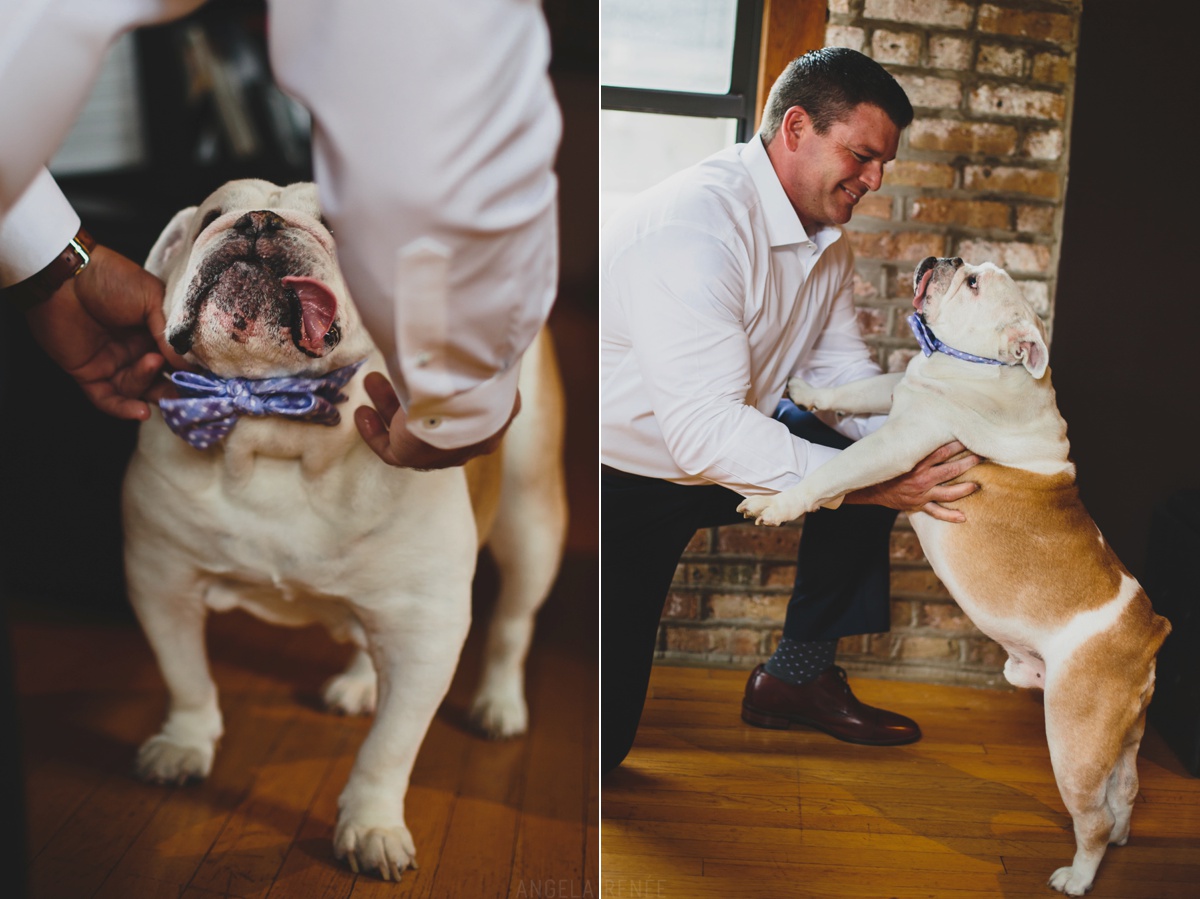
(770, 103), (900, 234)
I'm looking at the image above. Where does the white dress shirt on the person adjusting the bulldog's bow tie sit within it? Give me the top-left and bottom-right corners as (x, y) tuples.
(0, 0), (562, 449)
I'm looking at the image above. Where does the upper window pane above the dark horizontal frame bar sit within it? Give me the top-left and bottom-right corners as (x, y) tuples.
(600, 0), (738, 94)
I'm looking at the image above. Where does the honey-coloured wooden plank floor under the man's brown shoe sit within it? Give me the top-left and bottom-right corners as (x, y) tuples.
(609, 666), (1200, 899)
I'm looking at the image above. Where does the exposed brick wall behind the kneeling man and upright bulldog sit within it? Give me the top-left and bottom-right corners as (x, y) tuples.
(659, 0), (1081, 685)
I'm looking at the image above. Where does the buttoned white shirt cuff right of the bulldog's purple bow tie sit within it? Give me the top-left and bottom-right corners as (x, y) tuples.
(408, 362), (521, 450)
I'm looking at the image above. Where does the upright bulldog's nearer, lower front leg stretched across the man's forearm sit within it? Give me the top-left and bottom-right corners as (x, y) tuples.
(738, 418), (954, 526)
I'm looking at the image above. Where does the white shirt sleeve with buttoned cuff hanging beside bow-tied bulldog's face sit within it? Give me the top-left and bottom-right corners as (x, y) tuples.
(270, 0), (560, 449)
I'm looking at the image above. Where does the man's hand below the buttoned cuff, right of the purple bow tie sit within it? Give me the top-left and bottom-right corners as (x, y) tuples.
(354, 372), (521, 472)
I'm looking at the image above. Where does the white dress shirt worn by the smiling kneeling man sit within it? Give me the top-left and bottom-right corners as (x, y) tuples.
(600, 136), (883, 495)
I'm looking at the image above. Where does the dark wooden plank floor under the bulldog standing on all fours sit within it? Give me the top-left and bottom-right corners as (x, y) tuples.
(0, 547), (598, 899)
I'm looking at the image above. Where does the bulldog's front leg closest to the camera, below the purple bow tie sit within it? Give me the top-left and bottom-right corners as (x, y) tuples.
(334, 582), (470, 880)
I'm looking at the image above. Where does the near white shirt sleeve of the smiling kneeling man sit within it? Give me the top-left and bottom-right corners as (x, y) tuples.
(610, 224), (838, 495)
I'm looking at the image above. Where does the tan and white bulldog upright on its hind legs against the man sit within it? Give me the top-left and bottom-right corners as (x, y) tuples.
(739, 257), (1170, 895)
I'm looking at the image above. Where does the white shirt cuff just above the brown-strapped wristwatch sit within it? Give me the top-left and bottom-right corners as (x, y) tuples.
(0, 168), (80, 287)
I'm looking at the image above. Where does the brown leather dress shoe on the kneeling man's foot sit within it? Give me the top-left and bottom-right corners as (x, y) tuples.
(742, 665), (920, 747)
